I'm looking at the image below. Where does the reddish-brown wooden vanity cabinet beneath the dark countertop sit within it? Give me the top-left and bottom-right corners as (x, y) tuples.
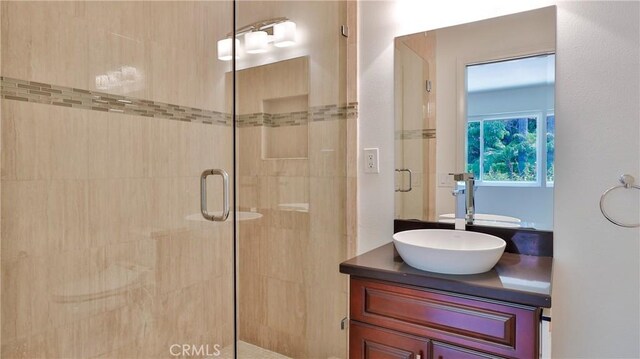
(349, 276), (541, 359)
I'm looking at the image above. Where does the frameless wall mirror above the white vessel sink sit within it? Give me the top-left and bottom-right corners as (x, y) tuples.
(394, 7), (556, 230)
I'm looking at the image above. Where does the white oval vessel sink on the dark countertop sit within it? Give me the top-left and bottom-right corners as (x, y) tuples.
(393, 229), (506, 274)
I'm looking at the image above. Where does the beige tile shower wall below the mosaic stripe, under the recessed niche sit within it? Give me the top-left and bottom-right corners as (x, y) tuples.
(238, 119), (347, 358)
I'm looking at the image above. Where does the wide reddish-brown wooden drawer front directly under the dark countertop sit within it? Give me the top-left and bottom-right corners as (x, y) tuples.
(350, 277), (540, 358)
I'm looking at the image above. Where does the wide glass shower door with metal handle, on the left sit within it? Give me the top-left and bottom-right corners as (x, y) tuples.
(0, 1), (234, 358)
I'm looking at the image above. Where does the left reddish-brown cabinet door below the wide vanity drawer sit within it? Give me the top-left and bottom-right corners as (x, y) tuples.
(349, 320), (429, 359)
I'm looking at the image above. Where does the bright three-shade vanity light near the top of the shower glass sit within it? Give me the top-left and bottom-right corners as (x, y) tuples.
(218, 17), (296, 61)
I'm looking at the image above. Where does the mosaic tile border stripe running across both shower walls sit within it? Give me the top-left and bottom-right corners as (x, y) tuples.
(0, 76), (358, 127)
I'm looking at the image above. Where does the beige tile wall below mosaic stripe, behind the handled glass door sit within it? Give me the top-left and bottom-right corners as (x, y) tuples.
(2, 100), (232, 357)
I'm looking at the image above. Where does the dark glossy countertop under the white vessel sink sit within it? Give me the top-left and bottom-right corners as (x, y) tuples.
(340, 243), (553, 308)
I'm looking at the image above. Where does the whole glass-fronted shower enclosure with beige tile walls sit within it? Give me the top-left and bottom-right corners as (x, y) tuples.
(0, 1), (356, 358)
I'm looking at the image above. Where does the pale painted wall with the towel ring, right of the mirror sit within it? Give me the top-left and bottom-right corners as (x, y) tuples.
(552, 1), (640, 358)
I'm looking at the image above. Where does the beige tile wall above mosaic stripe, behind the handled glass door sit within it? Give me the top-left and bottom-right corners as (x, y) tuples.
(2, 1), (232, 111)
